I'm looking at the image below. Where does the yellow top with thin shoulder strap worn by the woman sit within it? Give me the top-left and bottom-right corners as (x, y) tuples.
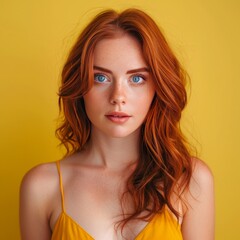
(51, 162), (183, 240)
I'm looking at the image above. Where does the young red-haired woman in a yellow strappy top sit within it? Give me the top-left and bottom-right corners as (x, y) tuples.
(20, 9), (214, 240)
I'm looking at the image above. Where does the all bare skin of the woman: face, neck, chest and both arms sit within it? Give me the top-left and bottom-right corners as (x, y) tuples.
(20, 34), (214, 240)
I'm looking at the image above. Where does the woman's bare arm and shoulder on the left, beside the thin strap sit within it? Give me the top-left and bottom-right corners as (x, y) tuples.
(20, 165), (54, 240)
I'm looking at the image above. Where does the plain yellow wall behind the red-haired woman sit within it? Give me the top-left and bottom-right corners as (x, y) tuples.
(0, 0), (240, 240)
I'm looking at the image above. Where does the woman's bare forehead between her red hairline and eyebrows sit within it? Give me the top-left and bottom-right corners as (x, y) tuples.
(93, 33), (147, 68)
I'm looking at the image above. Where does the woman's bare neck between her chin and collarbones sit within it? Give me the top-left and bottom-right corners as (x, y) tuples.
(87, 128), (140, 170)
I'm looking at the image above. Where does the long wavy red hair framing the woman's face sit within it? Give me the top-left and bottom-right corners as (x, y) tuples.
(56, 9), (192, 225)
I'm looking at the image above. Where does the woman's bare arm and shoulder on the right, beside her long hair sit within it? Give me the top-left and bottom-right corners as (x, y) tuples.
(182, 160), (215, 240)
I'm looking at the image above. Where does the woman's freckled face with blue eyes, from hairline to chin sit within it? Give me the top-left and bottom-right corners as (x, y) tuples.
(84, 34), (155, 138)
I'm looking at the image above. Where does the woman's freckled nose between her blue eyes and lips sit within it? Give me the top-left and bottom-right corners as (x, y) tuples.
(110, 82), (126, 105)
